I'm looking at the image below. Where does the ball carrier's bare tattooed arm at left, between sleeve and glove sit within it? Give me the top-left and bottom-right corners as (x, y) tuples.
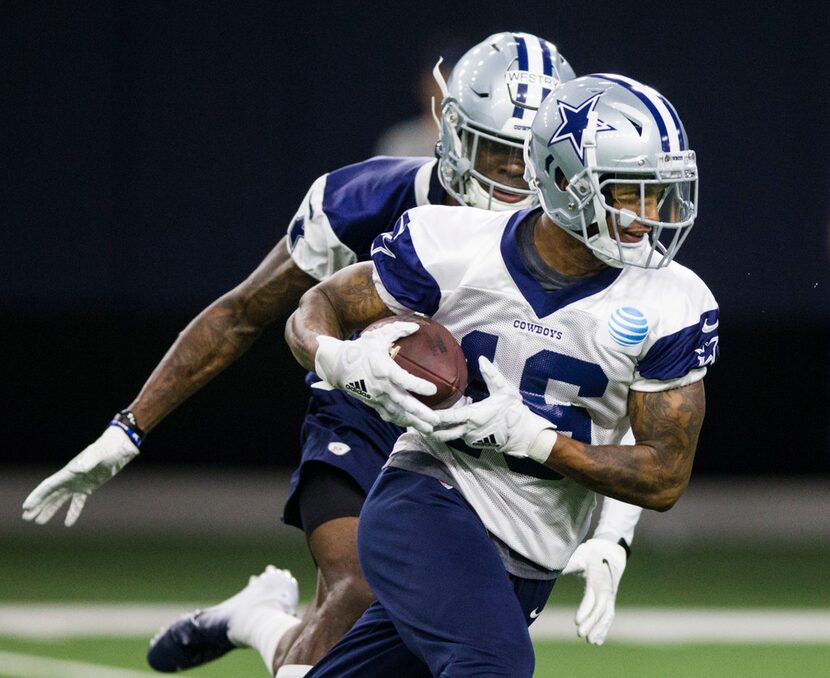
(285, 262), (392, 370)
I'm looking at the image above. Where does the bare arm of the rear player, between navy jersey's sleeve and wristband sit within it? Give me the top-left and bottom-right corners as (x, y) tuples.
(129, 238), (316, 431)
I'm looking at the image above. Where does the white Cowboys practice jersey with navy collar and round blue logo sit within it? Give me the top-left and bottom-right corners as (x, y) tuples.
(372, 206), (718, 570)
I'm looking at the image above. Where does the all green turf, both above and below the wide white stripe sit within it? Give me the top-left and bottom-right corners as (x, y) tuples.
(0, 530), (830, 678)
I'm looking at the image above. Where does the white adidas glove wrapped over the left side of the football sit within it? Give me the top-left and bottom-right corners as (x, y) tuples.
(314, 321), (438, 433)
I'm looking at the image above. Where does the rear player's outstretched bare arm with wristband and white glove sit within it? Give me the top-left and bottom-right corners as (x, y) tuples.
(23, 239), (315, 526)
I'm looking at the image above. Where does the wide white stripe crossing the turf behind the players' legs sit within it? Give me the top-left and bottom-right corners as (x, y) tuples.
(0, 603), (830, 644)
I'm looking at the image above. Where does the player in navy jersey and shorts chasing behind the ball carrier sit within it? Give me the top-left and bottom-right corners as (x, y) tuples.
(24, 33), (639, 675)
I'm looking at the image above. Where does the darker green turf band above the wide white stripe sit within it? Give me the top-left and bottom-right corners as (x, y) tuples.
(0, 526), (830, 608)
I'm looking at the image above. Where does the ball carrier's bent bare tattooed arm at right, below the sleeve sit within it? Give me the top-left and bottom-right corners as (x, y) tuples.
(547, 381), (706, 510)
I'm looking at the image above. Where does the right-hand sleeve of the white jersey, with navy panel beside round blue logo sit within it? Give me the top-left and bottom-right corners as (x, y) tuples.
(631, 269), (719, 391)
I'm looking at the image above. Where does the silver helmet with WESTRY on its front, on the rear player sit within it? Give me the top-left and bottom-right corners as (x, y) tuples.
(434, 33), (575, 210)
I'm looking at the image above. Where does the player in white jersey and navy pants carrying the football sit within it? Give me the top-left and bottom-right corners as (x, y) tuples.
(286, 74), (718, 678)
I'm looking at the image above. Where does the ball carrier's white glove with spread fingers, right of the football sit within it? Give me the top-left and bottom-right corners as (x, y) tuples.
(432, 356), (556, 463)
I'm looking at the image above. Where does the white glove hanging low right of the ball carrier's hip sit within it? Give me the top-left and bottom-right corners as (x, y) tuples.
(562, 539), (626, 645)
